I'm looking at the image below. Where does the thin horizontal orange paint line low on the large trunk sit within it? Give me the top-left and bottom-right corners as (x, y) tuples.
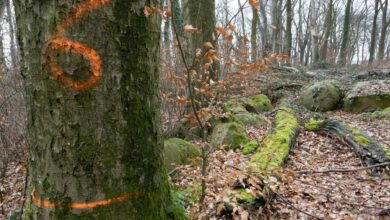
(31, 191), (148, 209)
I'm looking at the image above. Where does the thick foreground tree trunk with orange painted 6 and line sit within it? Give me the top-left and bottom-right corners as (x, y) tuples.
(15, 0), (175, 219)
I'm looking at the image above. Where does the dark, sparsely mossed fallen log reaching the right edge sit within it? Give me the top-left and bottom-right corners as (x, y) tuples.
(305, 119), (390, 175)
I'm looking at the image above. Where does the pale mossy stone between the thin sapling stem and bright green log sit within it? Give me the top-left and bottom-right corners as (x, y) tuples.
(211, 122), (248, 149)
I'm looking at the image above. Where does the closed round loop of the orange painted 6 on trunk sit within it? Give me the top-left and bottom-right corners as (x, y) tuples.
(49, 39), (102, 90)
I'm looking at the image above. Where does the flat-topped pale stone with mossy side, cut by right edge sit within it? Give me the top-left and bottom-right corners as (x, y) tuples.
(344, 80), (390, 112)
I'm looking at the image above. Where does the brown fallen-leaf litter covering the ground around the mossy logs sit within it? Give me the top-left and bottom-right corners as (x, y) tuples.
(172, 112), (390, 219)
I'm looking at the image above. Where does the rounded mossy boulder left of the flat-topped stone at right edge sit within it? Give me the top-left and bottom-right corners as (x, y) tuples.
(301, 81), (342, 112)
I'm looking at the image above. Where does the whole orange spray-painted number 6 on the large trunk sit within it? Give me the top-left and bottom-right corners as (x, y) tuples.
(48, 0), (111, 90)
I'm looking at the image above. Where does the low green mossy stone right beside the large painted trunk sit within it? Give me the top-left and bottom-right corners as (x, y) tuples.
(164, 138), (201, 168)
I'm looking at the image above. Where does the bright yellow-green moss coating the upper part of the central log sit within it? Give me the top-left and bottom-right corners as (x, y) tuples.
(250, 108), (299, 171)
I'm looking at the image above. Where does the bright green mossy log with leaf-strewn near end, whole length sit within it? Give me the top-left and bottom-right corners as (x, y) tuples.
(216, 107), (299, 214)
